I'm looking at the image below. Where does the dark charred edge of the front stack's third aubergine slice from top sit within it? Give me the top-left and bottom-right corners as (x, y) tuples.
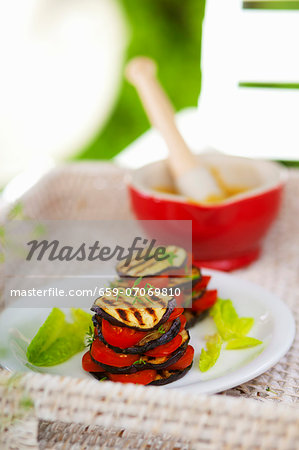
(90, 331), (190, 374)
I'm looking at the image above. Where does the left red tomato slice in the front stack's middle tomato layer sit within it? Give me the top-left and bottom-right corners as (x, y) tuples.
(90, 339), (140, 367)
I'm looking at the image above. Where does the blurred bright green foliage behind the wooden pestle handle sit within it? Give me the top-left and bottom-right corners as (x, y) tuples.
(78, 0), (205, 159)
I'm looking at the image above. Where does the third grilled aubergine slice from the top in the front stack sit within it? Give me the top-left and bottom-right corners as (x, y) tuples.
(90, 330), (190, 374)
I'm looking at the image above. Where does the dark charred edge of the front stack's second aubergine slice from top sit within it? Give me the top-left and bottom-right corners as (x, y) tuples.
(92, 316), (181, 355)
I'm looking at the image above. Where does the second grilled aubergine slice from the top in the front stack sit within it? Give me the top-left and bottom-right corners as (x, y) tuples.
(92, 315), (181, 355)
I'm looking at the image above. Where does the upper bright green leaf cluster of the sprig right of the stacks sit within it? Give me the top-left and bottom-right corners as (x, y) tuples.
(210, 299), (254, 341)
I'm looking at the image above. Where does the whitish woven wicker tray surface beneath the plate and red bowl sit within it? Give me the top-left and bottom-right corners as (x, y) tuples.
(0, 163), (299, 449)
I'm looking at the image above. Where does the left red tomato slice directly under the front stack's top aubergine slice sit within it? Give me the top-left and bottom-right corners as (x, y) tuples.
(102, 319), (147, 348)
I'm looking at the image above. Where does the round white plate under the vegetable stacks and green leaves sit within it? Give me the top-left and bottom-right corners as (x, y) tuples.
(0, 270), (295, 394)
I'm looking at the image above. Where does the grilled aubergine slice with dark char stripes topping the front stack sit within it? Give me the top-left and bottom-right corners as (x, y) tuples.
(91, 294), (176, 331)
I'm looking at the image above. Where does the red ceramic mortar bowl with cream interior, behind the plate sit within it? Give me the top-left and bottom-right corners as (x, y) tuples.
(129, 154), (286, 270)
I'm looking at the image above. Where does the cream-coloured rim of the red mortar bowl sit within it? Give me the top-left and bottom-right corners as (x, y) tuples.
(126, 153), (288, 209)
